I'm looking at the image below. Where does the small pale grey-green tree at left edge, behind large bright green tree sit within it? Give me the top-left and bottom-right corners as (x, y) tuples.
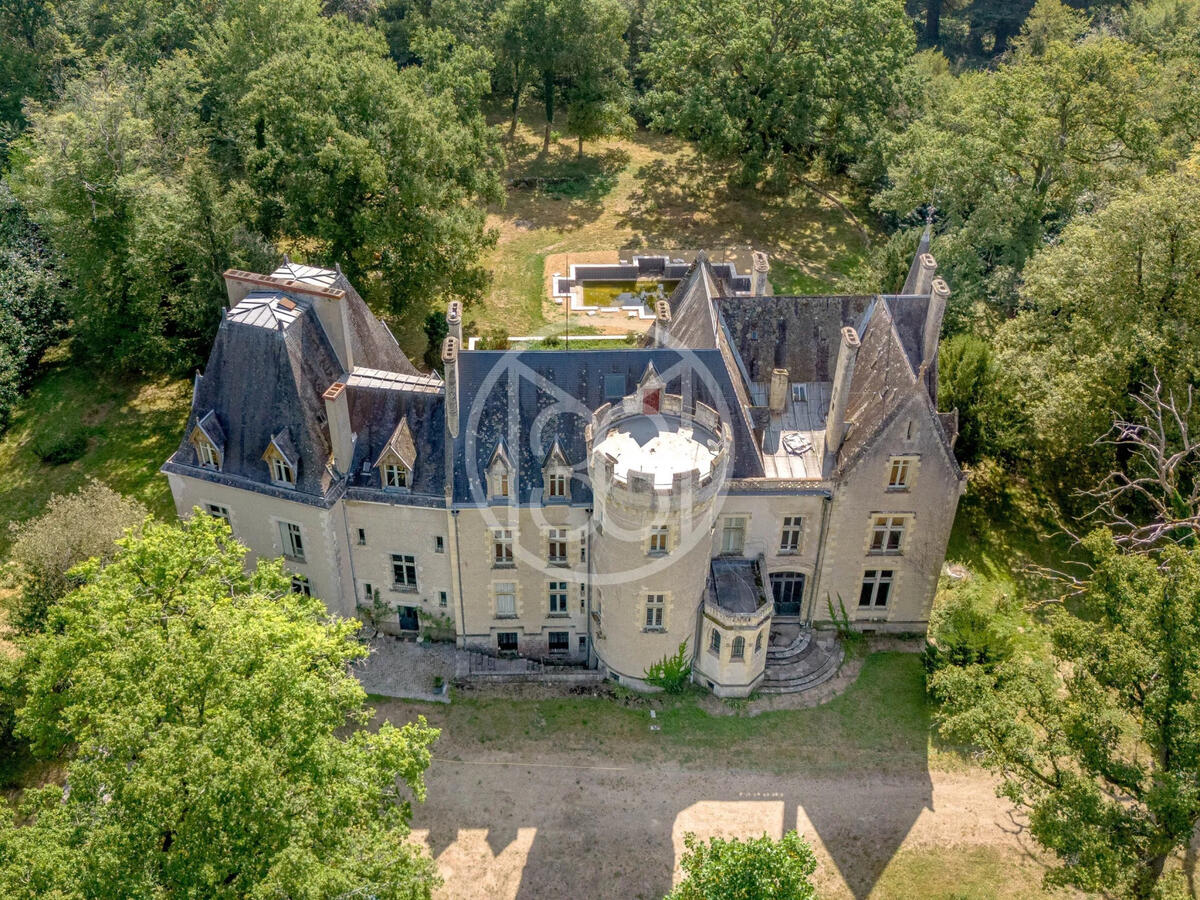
(8, 480), (150, 634)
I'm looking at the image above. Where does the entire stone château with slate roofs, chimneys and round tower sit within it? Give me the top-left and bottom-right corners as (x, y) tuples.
(163, 246), (965, 696)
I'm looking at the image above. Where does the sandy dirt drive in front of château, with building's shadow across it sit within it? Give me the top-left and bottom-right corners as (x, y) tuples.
(414, 755), (1051, 900)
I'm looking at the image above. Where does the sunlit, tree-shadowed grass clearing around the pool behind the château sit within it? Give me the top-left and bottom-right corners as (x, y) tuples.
(468, 118), (865, 343)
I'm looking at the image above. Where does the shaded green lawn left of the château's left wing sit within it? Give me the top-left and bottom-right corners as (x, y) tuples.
(0, 350), (191, 553)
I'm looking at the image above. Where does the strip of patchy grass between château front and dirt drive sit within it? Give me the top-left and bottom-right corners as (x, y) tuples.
(377, 653), (929, 773)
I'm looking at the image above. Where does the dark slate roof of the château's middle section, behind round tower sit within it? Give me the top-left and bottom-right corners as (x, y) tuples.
(454, 349), (763, 504)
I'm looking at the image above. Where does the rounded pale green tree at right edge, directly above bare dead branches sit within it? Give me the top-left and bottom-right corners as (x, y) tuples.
(995, 167), (1200, 484)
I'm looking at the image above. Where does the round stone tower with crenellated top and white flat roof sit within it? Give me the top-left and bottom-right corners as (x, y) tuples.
(587, 377), (731, 688)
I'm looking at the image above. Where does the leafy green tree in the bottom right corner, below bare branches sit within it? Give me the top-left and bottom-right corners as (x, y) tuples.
(932, 530), (1200, 900)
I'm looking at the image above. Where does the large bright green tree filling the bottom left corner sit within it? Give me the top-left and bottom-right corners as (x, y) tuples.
(0, 510), (437, 900)
